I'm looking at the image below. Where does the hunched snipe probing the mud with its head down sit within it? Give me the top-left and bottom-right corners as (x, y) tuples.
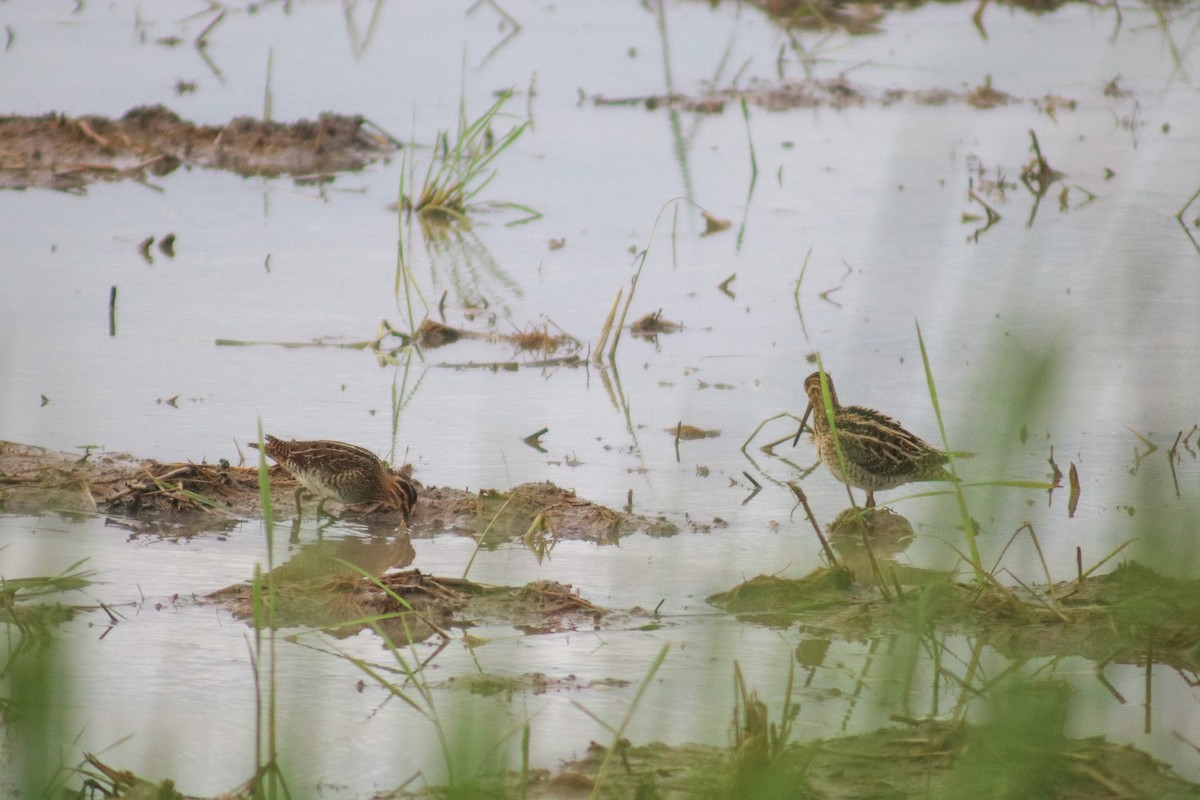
(250, 435), (416, 524)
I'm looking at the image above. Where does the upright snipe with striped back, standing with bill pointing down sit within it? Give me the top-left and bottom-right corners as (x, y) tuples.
(793, 372), (955, 509)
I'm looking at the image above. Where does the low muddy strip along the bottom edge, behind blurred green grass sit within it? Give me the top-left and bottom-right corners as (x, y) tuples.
(516, 721), (1196, 800)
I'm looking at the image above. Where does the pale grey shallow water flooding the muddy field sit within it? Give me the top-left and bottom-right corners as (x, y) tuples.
(0, 2), (1200, 796)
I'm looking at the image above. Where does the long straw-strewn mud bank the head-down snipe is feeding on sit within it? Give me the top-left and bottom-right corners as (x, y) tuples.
(0, 441), (678, 547)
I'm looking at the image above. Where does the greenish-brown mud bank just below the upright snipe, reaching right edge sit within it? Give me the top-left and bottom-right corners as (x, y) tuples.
(708, 563), (1200, 681)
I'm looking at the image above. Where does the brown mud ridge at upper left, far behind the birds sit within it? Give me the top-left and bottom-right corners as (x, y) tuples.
(0, 106), (396, 192)
